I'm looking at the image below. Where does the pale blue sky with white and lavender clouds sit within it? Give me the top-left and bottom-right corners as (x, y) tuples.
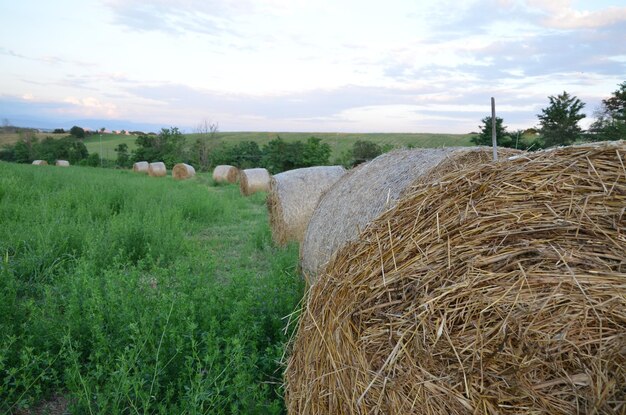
(0, 0), (626, 133)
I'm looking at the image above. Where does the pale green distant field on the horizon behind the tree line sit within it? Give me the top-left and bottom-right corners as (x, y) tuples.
(0, 132), (473, 160)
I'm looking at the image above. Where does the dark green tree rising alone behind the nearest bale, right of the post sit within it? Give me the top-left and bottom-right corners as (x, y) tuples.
(537, 91), (586, 147)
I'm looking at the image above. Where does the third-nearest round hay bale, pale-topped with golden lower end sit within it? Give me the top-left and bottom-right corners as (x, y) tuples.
(267, 166), (346, 245)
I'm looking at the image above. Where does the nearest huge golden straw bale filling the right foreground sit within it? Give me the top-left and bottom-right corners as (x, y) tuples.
(285, 141), (626, 414)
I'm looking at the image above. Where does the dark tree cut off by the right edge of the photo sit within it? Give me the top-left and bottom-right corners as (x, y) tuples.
(589, 81), (626, 141)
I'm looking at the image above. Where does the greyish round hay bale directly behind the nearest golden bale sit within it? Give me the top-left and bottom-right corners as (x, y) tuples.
(300, 147), (521, 284)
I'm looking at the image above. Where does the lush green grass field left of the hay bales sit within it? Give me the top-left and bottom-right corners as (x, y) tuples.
(0, 162), (303, 414)
